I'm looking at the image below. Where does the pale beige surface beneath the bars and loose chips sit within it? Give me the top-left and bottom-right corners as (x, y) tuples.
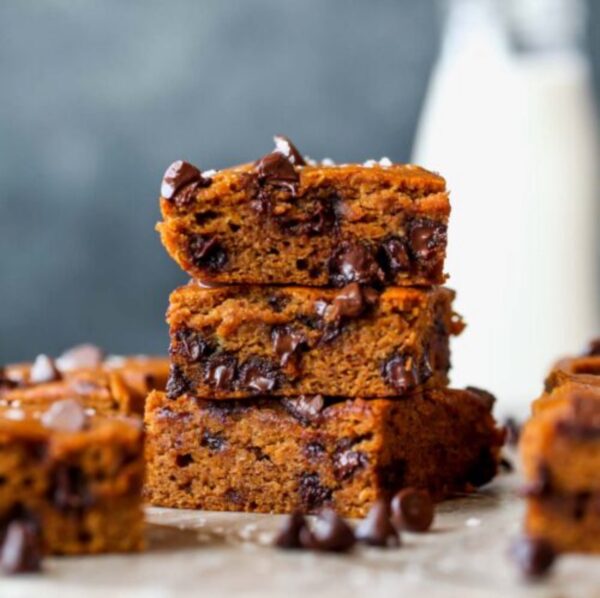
(0, 468), (600, 598)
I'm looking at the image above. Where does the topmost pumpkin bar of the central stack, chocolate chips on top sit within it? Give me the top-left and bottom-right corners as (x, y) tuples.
(157, 136), (450, 286)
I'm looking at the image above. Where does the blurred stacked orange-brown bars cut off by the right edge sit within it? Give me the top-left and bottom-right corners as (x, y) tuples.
(520, 382), (600, 552)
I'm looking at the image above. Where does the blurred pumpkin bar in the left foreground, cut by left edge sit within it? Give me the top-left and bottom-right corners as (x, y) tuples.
(0, 399), (144, 554)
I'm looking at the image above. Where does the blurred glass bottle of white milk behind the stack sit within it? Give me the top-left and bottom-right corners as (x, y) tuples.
(413, 0), (599, 415)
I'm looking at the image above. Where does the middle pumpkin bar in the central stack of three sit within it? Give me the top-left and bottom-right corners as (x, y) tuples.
(167, 281), (462, 399)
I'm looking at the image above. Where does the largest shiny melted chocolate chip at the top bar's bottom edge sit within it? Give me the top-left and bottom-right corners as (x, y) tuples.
(328, 241), (385, 286)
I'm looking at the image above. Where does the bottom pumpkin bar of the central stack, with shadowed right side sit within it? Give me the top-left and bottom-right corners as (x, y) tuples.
(146, 389), (503, 517)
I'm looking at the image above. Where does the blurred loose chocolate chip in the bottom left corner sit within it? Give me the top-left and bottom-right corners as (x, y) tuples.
(0, 519), (42, 574)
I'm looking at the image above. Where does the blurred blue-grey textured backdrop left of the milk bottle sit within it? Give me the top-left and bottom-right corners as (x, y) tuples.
(0, 0), (600, 363)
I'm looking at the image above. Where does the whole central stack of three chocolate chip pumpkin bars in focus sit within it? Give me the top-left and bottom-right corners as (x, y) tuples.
(145, 137), (502, 517)
